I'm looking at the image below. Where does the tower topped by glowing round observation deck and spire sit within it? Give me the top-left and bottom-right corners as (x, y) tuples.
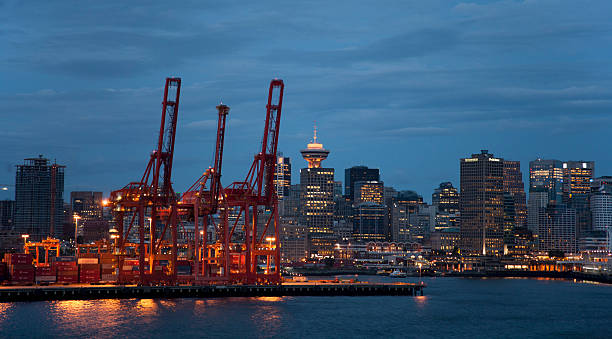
(300, 128), (335, 257)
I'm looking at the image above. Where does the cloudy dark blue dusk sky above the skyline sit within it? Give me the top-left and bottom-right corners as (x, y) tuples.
(0, 0), (612, 201)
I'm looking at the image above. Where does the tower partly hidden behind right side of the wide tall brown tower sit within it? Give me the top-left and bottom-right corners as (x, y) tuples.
(504, 159), (527, 228)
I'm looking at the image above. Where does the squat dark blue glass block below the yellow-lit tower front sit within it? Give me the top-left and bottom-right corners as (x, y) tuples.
(353, 202), (388, 242)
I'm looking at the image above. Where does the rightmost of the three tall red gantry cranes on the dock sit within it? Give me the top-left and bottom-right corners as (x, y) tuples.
(221, 79), (284, 284)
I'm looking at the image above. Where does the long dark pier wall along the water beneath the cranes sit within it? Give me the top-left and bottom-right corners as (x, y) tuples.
(0, 283), (425, 302)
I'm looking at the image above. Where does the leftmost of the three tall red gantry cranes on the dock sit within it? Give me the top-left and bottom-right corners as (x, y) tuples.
(110, 77), (181, 284)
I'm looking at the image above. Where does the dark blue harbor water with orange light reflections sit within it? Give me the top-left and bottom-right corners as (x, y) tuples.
(0, 276), (612, 338)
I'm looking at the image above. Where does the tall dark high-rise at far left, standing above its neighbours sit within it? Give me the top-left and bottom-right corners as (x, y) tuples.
(14, 155), (65, 241)
